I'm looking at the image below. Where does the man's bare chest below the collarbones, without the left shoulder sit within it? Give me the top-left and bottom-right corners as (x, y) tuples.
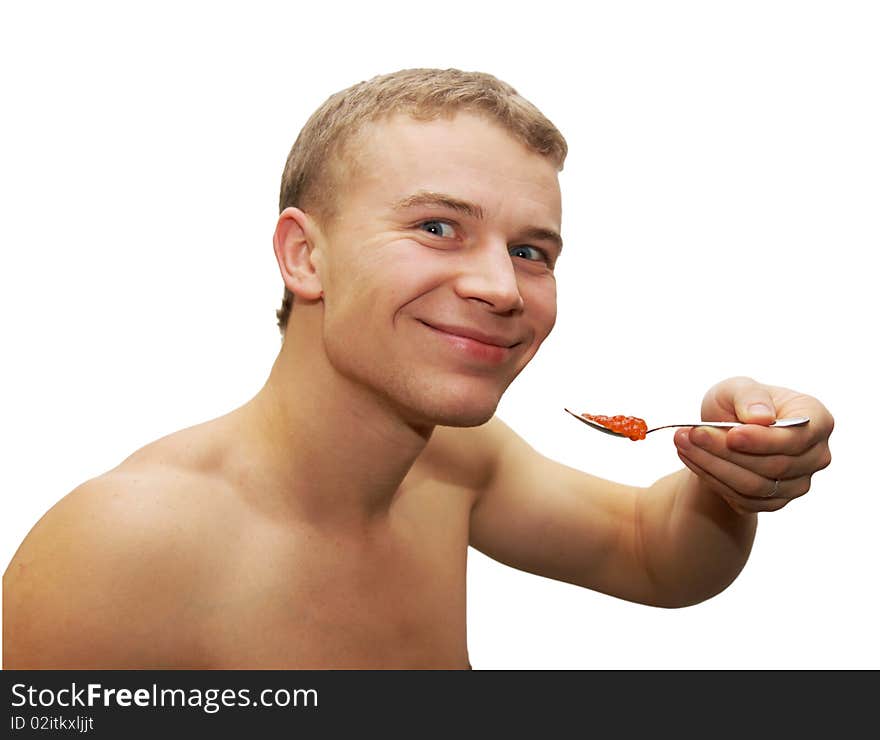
(198, 474), (478, 669)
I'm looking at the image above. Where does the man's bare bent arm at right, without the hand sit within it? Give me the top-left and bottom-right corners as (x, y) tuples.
(471, 418), (757, 607)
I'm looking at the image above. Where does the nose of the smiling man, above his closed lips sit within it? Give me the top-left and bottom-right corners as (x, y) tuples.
(455, 241), (523, 314)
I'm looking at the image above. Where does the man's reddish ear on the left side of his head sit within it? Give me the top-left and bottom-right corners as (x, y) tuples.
(272, 206), (324, 301)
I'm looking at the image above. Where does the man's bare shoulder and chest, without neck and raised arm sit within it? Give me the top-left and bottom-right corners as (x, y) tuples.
(4, 404), (482, 668)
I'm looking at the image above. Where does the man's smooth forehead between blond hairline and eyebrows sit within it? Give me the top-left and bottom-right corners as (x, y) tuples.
(350, 113), (561, 229)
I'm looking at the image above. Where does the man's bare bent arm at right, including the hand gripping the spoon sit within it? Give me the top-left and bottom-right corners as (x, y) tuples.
(471, 375), (834, 607)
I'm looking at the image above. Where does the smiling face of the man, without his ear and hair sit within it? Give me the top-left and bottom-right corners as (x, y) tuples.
(319, 114), (561, 426)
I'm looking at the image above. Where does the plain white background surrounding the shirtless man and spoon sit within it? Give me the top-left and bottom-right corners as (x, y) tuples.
(0, 0), (880, 672)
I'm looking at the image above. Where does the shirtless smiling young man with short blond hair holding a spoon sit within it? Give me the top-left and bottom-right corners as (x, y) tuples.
(4, 70), (833, 668)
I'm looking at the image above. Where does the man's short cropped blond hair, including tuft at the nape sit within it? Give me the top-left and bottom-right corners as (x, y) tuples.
(275, 69), (568, 338)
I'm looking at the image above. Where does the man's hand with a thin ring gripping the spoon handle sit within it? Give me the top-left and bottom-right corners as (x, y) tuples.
(674, 377), (834, 514)
